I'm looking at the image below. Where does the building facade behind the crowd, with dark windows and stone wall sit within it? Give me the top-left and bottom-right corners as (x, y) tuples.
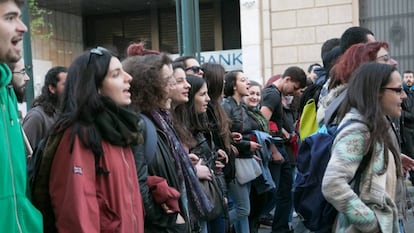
(32, 0), (414, 89)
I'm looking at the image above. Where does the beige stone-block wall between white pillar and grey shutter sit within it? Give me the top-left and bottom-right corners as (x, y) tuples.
(267, 0), (358, 78)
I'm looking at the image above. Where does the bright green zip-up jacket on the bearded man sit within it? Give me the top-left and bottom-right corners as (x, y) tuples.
(0, 64), (43, 233)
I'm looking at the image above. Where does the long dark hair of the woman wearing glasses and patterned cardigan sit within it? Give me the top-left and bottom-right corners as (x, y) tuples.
(338, 62), (403, 176)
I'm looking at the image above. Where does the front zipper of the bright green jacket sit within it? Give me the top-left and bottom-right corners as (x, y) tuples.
(1, 104), (23, 233)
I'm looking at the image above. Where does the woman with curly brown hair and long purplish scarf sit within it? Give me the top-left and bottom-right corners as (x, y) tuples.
(123, 44), (212, 233)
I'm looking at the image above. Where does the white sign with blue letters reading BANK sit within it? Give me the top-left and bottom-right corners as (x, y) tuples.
(171, 49), (243, 71)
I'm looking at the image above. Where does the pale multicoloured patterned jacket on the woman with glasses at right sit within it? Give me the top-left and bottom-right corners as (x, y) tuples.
(322, 109), (399, 233)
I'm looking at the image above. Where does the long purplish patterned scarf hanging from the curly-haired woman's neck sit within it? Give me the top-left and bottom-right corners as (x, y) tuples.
(151, 110), (213, 217)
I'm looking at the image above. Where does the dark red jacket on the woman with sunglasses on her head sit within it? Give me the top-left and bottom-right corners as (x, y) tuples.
(49, 130), (144, 233)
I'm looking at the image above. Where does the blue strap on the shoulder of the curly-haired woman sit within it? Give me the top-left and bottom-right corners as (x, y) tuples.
(141, 114), (158, 162)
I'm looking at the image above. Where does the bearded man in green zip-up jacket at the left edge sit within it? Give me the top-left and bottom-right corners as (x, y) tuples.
(0, 0), (43, 233)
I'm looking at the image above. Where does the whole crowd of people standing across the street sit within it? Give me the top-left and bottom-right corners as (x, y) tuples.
(0, 0), (414, 233)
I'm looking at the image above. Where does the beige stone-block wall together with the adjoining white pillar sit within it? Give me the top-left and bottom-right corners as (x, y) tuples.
(240, 0), (359, 83)
